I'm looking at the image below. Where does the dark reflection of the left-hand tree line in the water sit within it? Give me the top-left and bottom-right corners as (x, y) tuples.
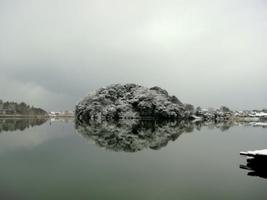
(0, 118), (48, 133)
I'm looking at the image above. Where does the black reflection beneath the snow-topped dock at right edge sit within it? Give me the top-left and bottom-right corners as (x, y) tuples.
(240, 156), (267, 179)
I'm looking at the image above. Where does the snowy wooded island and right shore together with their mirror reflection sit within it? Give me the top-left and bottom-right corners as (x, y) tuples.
(75, 84), (267, 152)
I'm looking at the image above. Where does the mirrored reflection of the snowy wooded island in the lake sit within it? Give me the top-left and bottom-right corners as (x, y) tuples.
(75, 120), (266, 152)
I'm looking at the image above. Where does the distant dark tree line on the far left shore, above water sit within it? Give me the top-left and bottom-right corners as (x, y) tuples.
(0, 100), (47, 115)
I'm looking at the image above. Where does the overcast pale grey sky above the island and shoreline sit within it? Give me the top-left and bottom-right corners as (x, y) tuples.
(0, 0), (267, 110)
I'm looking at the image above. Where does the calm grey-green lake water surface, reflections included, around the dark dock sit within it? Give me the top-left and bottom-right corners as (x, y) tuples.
(0, 119), (267, 200)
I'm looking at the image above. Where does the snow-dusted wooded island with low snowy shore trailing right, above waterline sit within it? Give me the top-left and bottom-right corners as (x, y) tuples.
(75, 84), (267, 123)
